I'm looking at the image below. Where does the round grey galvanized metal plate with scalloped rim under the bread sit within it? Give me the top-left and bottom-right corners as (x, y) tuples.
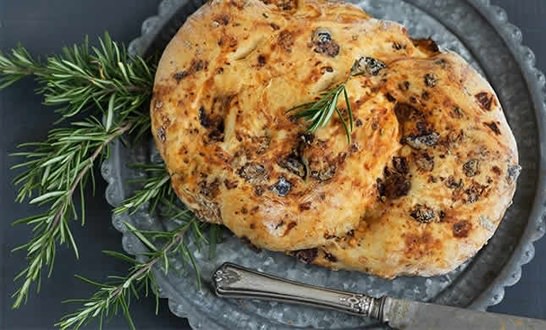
(102, 0), (546, 329)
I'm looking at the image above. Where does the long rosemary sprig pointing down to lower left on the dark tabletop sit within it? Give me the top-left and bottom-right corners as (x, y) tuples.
(13, 119), (131, 308)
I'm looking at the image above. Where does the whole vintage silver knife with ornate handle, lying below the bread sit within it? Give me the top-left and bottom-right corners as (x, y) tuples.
(212, 263), (546, 330)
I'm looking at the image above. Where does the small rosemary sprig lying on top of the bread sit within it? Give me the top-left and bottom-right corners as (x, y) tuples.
(289, 84), (354, 144)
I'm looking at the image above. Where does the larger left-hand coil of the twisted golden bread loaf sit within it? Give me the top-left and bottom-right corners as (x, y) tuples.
(152, 1), (424, 251)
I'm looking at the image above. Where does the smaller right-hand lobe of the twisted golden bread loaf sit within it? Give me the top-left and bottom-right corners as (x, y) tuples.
(313, 54), (519, 278)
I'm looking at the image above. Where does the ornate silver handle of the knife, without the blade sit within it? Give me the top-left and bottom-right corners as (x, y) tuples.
(212, 263), (385, 320)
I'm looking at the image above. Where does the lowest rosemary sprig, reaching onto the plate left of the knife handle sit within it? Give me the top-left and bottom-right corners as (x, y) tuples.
(56, 217), (200, 329)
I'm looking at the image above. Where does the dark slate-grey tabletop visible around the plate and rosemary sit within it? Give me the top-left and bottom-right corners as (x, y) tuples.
(0, 0), (546, 329)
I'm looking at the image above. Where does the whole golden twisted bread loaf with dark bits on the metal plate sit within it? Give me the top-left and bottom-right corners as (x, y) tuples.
(151, 0), (519, 277)
